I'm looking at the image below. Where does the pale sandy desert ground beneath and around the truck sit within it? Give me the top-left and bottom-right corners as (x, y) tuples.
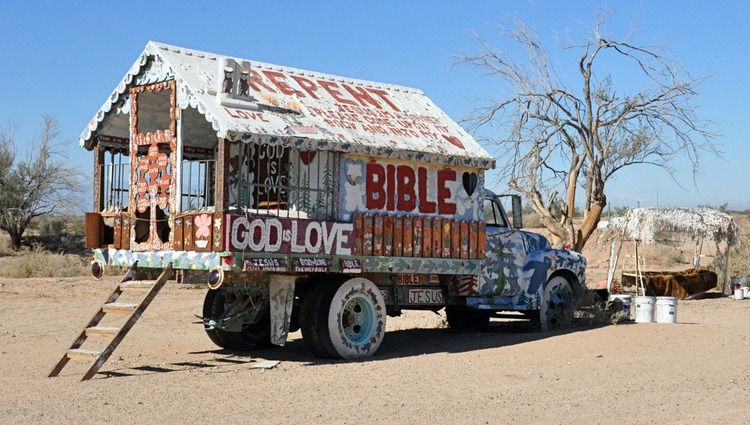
(0, 260), (750, 424)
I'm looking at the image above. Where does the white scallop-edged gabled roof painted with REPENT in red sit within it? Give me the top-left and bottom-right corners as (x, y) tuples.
(80, 42), (494, 168)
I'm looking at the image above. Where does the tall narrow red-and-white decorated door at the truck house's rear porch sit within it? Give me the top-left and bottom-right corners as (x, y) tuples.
(130, 80), (177, 251)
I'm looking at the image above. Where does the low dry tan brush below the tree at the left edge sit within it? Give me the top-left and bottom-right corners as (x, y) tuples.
(0, 248), (89, 279)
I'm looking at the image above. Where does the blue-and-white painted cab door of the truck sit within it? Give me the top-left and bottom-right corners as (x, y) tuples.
(479, 197), (526, 297)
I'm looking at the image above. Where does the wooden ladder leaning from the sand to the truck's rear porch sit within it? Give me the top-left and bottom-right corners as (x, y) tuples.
(49, 263), (172, 381)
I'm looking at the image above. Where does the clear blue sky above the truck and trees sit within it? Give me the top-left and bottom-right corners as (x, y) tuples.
(0, 0), (750, 209)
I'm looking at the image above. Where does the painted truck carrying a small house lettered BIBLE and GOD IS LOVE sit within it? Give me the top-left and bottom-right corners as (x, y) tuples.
(74, 42), (586, 359)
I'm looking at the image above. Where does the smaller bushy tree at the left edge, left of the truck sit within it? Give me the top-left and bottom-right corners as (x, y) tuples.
(0, 115), (83, 250)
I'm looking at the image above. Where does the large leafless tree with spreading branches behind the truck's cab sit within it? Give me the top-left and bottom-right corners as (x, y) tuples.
(458, 14), (720, 251)
